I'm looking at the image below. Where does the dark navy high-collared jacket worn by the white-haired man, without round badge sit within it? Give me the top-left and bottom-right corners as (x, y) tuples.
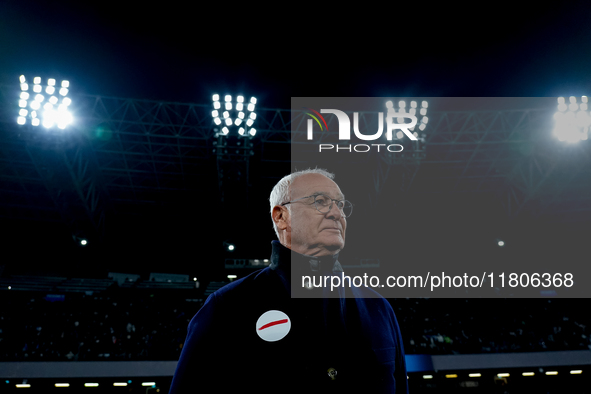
(170, 241), (408, 394)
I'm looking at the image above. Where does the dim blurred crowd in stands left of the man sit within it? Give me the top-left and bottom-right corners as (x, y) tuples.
(0, 292), (202, 361)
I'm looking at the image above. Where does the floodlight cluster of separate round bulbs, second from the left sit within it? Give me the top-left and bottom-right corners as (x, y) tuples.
(211, 94), (257, 137)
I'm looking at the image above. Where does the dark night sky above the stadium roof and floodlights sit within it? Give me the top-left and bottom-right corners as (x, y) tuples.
(0, 0), (591, 280)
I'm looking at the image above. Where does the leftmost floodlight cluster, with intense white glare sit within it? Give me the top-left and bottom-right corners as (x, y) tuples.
(17, 75), (72, 129)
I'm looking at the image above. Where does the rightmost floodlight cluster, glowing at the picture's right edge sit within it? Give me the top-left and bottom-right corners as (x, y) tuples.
(554, 96), (591, 142)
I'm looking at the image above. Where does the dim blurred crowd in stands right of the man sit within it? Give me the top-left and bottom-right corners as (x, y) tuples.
(398, 298), (591, 354)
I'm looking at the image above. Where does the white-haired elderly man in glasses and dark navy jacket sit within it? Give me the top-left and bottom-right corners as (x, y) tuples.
(170, 169), (408, 394)
